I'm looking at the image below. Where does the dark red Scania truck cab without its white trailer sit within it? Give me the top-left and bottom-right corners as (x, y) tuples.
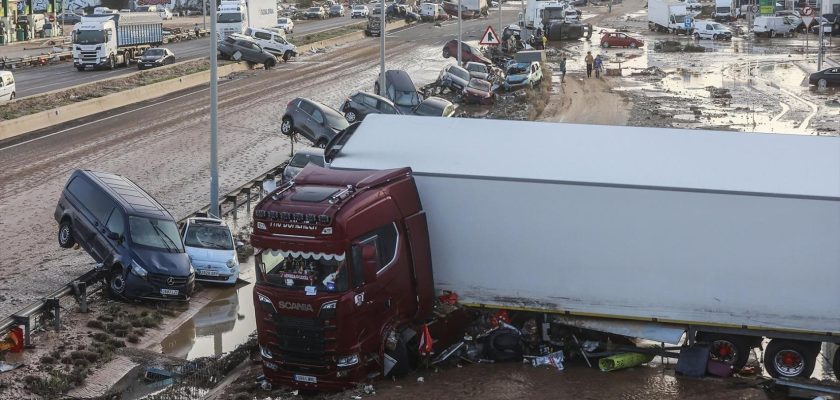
(251, 166), (434, 390)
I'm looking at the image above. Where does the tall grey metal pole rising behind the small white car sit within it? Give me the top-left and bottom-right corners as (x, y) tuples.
(210, 0), (221, 217)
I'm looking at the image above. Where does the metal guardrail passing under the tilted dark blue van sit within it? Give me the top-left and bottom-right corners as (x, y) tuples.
(0, 161), (288, 347)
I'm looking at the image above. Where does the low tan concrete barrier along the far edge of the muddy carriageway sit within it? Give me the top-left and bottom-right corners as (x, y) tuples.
(0, 63), (248, 141)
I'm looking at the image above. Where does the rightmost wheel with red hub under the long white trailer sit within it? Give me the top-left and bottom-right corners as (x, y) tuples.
(764, 339), (819, 378)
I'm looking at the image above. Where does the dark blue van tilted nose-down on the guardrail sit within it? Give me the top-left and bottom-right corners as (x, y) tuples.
(55, 170), (195, 300)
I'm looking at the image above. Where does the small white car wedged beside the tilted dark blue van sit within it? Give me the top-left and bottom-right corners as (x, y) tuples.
(181, 217), (239, 285)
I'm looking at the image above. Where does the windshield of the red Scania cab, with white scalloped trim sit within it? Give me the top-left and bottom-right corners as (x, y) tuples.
(262, 251), (349, 292)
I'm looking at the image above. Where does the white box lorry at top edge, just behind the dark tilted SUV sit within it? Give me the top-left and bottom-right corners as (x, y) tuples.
(216, 0), (277, 40)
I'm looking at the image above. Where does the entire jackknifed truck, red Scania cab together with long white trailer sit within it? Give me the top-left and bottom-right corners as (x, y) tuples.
(251, 114), (840, 389)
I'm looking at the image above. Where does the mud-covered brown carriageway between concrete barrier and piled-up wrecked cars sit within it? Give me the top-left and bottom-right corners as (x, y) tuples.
(0, 12), (516, 315)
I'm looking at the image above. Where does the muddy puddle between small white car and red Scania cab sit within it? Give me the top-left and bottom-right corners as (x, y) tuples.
(161, 257), (257, 360)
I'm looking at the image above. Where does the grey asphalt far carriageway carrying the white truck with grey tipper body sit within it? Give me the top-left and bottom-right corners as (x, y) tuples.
(15, 15), (362, 98)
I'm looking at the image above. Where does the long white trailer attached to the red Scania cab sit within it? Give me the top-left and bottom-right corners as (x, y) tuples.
(326, 114), (840, 376)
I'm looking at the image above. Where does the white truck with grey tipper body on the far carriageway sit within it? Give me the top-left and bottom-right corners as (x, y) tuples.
(72, 13), (163, 71)
